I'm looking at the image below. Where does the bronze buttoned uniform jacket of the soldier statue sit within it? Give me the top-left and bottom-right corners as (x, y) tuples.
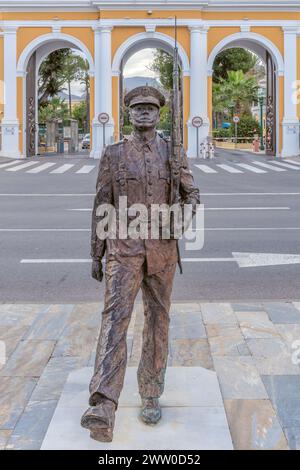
(91, 133), (200, 274)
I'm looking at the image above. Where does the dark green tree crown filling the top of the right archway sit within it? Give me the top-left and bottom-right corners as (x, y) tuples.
(213, 47), (258, 83)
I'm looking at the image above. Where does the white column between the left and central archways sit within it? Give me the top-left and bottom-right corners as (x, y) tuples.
(90, 26), (114, 158)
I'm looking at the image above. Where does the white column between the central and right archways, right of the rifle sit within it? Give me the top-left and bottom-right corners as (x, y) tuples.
(187, 26), (209, 157)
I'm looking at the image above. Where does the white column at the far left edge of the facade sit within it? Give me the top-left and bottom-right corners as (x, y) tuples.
(1, 27), (21, 158)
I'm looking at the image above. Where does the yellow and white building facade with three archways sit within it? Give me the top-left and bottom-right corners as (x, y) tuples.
(0, 0), (300, 158)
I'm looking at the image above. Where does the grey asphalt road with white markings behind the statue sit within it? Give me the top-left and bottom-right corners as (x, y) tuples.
(0, 151), (300, 303)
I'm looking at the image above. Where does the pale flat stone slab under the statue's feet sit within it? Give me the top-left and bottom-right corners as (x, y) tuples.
(41, 367), (232, 450)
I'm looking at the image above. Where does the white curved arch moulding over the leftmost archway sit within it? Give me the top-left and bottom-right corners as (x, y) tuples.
(17, 32), (95, 75)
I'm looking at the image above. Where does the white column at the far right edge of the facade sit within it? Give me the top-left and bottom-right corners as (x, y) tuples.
(282, 27), (300, 157)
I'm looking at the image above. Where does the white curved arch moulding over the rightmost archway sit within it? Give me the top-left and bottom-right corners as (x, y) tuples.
(207, 32), (284, 75)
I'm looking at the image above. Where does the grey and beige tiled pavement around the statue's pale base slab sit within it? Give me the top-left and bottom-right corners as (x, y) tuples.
(0, 302), (300, 449)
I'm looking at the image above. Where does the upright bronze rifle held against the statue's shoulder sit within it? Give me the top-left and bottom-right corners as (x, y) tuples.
(169, 16), (182, 274)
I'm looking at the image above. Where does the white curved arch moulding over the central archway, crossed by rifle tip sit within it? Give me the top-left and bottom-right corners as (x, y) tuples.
(112, 32), (190, 75)
